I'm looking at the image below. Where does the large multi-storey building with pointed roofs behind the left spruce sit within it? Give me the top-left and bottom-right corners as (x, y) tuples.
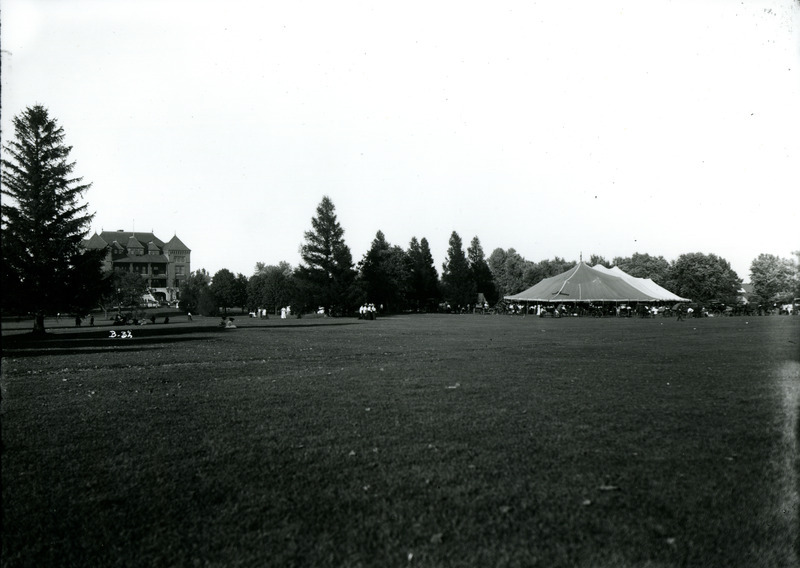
(83, 229), (191, 302)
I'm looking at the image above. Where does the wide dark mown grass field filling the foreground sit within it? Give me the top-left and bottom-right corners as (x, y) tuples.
(2, 315), (800, 567)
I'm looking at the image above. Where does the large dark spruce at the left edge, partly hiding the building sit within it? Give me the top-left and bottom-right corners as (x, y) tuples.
(2, 105), (104, 335)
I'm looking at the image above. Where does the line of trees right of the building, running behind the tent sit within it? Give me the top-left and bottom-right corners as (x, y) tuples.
(182, 196), (800, 315)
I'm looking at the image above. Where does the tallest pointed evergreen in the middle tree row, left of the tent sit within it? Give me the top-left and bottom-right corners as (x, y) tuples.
(297, 196), (357, 313)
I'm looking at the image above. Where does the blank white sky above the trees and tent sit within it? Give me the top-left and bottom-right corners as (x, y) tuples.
(0, 0), (800, 281)
